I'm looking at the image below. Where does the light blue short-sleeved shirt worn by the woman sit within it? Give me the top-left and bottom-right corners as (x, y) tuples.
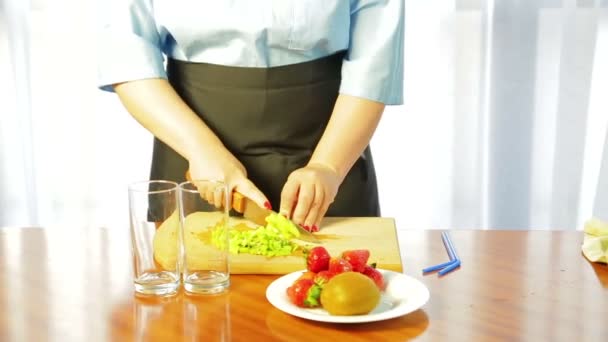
(98, 0), (404, 105)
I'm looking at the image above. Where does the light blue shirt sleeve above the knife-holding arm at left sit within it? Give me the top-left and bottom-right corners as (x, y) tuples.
(97, 0), (167, 91)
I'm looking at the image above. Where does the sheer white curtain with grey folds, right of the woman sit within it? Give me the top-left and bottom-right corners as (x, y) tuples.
(374, 0), (608, 229)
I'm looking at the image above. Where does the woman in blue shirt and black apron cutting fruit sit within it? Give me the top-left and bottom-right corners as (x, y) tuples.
(99, 0), (403, 231)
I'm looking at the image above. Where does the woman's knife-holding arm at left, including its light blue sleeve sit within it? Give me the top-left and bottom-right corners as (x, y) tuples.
(97, 0), (266, 205)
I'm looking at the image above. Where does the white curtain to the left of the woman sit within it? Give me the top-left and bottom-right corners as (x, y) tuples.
(0, 0), (152, 227)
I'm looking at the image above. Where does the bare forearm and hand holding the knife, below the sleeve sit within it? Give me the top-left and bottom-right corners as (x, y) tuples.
(114, 79), (267, 205)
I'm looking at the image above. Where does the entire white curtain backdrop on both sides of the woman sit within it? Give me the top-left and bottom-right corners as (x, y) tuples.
(0, 0), (608, 229)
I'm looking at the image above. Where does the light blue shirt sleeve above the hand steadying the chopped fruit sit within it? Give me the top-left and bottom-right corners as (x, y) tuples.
(340, 0), (404, 105)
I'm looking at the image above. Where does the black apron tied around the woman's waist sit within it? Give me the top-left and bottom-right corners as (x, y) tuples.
(150, 53), (380, 216)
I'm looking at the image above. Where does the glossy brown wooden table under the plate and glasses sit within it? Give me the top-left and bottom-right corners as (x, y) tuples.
(0, 228), (608, 342)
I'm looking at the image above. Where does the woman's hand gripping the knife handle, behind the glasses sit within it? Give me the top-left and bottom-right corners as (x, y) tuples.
(187, 152), (270, 208)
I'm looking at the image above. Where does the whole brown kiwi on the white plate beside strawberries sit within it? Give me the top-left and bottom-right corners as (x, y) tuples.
(321, 272), (380, 316)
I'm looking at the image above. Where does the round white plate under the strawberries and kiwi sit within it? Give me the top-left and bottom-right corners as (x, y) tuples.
(266, 270), (430, 323)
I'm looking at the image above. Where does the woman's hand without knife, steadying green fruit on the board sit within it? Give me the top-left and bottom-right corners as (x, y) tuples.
(280, 163), (341, 231)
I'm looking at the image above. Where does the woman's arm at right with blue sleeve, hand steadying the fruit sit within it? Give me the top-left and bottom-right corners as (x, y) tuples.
(281, 0), (404, 230)
